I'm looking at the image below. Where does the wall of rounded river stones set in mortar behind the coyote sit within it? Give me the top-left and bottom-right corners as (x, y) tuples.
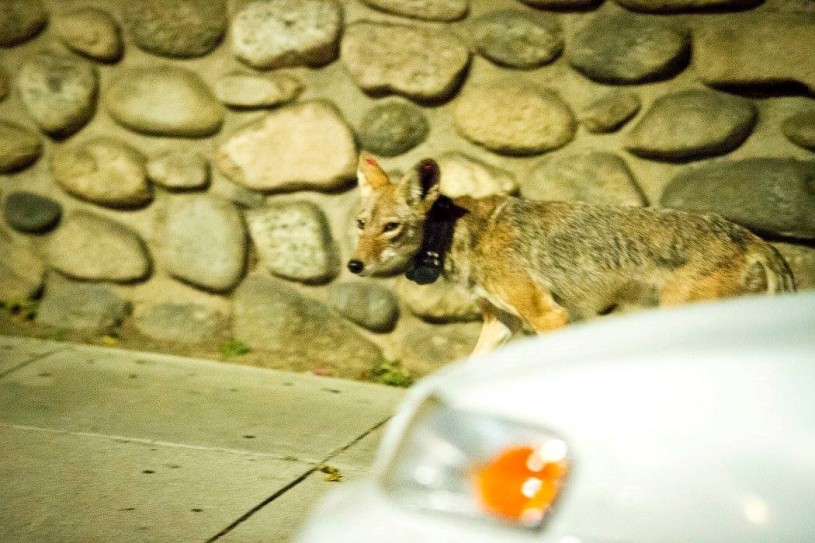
(0, 0), (815, 377)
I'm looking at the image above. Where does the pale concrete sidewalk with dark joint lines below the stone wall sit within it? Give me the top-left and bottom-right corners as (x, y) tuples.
(0, 336), (402, 543)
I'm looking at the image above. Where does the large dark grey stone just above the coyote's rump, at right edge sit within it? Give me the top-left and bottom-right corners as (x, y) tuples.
(660, 158), (815, 239)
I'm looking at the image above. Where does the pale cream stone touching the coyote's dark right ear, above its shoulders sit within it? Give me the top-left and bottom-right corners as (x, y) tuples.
(437, 151), (518, 198)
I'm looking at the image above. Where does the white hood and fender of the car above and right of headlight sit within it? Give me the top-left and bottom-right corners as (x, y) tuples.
(378, 293), (815, 542)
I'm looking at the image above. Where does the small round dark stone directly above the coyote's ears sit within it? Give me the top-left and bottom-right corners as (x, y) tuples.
(359, 101), (430, 156)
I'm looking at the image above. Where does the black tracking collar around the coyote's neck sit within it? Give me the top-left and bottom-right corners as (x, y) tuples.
(405, 196), (463, 285)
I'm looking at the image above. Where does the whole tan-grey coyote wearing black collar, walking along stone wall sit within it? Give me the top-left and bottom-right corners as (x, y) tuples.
(348, 154), (795, 355)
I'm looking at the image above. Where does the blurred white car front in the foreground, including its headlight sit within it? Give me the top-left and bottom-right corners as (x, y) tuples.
(296, 293), (815, 543)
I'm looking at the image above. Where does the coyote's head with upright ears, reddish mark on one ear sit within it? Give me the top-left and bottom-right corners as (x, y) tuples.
(348, 154), (439, 275)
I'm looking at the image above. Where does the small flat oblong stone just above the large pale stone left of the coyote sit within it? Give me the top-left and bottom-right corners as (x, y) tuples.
(215, 73), (303, 108)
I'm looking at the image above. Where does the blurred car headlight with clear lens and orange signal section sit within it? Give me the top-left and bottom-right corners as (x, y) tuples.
(381, 398), (570, 527)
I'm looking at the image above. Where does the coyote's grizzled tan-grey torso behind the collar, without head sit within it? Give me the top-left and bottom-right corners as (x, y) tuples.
(460, 201), (795, 321)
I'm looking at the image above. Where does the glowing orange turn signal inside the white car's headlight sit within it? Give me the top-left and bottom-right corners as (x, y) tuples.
(475, 440), (569, 524)
